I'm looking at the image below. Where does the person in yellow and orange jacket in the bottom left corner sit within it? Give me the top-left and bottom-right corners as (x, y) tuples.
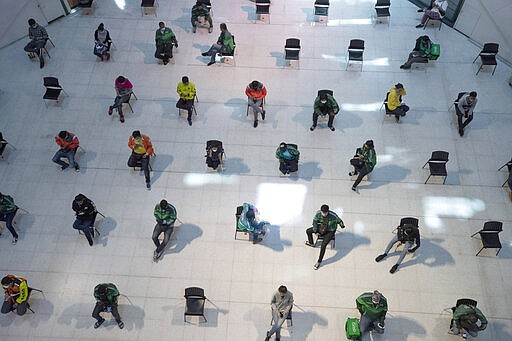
(2, 275), (28, 315)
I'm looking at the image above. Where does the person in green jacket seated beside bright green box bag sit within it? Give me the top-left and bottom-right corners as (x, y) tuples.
(356, 290), (388, 334)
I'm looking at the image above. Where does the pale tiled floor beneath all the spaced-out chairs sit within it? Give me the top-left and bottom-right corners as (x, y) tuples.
(0, 0), (512, 341)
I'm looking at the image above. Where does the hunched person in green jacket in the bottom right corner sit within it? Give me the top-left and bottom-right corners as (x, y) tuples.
(452, 304), (487, 338)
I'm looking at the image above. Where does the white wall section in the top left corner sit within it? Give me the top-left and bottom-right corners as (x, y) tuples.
(0, 0), (64, 48)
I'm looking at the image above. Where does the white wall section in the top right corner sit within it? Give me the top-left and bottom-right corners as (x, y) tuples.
(454, 0), (512, 63)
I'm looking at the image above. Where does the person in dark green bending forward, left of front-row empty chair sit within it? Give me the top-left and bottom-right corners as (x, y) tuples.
(92, 283), (124, 329)
